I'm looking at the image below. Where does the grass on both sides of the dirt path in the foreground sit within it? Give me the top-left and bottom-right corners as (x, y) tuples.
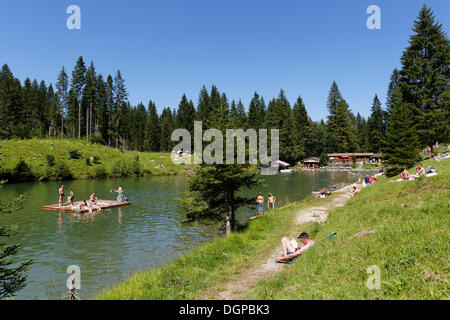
(96, 160), (450, 299)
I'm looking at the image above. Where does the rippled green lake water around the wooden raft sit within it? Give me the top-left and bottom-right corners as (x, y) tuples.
(0, 172), (354, 299)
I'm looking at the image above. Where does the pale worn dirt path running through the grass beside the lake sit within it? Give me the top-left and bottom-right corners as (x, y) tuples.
(200, 182), (361, 300)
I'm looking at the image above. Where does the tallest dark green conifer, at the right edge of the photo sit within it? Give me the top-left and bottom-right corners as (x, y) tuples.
(400, 5), (450, 146)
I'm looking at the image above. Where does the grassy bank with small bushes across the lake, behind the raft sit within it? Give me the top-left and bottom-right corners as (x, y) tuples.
(0, 139), (192, 181)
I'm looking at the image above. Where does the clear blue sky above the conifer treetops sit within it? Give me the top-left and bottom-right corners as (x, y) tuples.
(0, 0), (450, 120)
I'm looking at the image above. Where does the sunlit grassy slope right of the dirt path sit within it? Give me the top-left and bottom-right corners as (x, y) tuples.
(248, 160), (450, 299)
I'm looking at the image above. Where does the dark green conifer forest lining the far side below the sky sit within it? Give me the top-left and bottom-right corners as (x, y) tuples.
(0, 6), (450, 168)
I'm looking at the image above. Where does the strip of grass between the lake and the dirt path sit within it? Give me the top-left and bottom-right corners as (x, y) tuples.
(96, 198), (324, 300)
